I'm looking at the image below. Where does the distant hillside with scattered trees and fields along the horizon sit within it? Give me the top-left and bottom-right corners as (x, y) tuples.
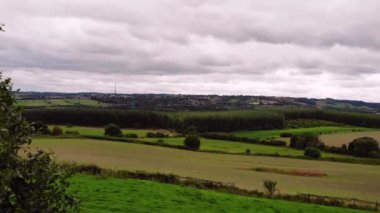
(17, 92), (380, 113)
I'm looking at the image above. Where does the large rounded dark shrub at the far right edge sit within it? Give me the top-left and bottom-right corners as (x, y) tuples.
(348, 137), (379, 157)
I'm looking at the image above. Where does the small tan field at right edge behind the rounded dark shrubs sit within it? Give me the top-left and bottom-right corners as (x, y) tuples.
(320, 131), (380, 147)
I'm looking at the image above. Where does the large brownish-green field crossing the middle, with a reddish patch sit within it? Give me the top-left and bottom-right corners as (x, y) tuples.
(32, 139), (380, 201)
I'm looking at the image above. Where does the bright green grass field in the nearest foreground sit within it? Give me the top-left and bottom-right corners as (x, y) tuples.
(69, 175), (364, 213)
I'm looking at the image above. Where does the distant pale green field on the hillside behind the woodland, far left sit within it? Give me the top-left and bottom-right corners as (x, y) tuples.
(17, 99), (107, 107)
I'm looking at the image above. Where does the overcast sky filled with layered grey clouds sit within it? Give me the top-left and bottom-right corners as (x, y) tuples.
(0, 0), (380, 102)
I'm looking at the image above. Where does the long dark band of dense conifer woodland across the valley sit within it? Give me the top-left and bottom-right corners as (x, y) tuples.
(23, 108), (380, 132)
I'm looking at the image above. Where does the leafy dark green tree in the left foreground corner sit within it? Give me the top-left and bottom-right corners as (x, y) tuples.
(0, 73), (78, 213)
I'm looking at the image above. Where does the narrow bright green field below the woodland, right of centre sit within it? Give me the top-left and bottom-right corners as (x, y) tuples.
(232, 126), (373, 139)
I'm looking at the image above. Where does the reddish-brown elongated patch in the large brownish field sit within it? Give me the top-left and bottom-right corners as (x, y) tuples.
(249, 167), (327, 177)
